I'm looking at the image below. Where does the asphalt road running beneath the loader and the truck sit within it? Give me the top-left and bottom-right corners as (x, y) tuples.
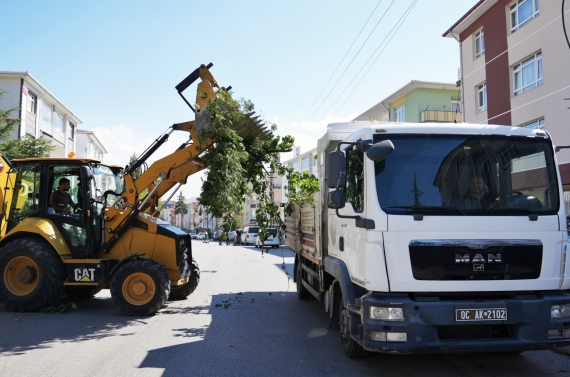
(0, 242), (570, 377)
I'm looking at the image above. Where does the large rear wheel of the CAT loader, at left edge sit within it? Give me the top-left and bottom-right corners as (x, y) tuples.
(0, 238), (67, 312)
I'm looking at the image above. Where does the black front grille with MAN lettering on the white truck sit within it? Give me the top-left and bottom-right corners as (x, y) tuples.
(409, 240), (542, 280)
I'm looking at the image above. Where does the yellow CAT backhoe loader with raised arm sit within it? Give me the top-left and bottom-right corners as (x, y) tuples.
(0, 63), (270, 316)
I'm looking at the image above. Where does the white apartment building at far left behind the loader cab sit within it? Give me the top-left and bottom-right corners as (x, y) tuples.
(0, 71), (82, 157)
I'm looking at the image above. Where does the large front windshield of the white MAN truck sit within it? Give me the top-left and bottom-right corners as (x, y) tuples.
(374, 135), (559, 216)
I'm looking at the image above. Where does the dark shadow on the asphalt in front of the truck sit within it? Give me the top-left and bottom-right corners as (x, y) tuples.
(136, 292), (570, 377)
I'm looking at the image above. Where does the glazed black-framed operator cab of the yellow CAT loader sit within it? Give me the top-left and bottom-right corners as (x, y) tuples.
(6, 159), (122, 258)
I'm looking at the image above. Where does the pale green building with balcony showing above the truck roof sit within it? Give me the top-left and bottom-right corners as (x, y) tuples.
(354, 80), (462, 123)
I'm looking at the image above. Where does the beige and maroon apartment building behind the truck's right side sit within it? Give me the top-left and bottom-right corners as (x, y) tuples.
(443, 0), (570, 208)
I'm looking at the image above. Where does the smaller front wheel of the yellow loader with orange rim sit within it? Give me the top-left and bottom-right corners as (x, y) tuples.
(111, 259), (170, 316)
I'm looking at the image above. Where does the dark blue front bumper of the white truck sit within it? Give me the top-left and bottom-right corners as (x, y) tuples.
(358, 291), (570, 353)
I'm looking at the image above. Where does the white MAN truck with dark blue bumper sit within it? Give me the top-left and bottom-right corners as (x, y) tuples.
(286, 122), (570, 357)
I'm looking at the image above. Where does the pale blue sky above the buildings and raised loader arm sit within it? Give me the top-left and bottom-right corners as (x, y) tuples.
(0, 0), (477, 198)
